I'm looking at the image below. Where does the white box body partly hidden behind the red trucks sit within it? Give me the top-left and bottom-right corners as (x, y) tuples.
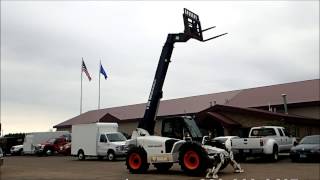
(23, 131), (70, 154)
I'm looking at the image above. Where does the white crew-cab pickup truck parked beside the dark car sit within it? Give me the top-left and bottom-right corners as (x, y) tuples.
(231, 126), (297, 161)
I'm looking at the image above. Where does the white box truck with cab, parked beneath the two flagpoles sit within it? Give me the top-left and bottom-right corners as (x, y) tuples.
(71, 123), (127, 160)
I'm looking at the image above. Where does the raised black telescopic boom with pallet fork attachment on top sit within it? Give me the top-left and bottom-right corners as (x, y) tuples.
(138, 8), (227, 135)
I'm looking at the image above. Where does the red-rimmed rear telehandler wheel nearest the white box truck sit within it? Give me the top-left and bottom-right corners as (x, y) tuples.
(126, 147), (149, 174)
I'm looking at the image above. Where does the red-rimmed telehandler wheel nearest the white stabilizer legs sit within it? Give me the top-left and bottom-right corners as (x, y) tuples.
(179, 142), (210, 176)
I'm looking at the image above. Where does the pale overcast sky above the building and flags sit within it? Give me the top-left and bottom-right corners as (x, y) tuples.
(1, 1), (319, 134)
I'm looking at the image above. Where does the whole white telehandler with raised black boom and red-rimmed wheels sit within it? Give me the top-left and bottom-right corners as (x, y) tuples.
(126, 9), (243, 178)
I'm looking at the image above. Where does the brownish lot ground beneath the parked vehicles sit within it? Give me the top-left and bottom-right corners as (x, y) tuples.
(0, 156), (320, 180)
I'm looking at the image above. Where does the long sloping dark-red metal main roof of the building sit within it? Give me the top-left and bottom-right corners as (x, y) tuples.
(54, 79), (320, 128)
